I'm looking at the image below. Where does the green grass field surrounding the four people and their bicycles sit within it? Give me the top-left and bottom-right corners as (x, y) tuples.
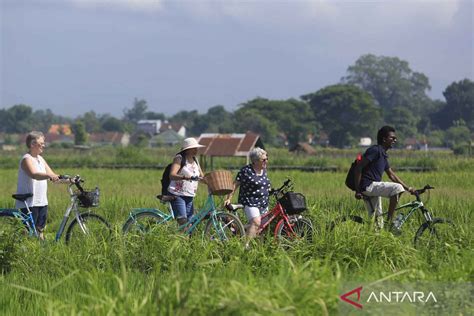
(0, 168), (474, 315)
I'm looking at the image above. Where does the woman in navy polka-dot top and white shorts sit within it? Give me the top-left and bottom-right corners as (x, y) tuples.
(224, 147), (271, 238)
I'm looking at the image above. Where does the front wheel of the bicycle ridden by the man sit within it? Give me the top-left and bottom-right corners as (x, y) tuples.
(414, 218), (455, 249)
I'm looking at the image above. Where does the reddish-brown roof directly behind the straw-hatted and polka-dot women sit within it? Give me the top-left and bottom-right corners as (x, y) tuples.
(198, 132), (263, 157)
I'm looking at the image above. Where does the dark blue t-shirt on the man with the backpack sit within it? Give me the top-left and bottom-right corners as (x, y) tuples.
(360, 145), (390, 191)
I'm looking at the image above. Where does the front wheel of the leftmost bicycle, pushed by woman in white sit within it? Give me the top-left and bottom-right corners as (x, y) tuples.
(66, 213), (112, 243)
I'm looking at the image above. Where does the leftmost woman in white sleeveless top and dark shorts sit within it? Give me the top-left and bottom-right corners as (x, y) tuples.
(16, 131), (59, 239)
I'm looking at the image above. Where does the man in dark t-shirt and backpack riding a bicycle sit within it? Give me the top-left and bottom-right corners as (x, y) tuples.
(354, 126), (414, 228)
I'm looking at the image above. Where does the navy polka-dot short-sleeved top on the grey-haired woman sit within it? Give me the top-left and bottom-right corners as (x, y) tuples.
(235, 165), (271, 211)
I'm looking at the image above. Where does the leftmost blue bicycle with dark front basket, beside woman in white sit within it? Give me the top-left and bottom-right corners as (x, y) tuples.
(0, 176), (112, 243)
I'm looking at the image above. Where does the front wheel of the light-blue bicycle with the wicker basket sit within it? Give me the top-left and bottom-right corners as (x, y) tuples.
(204, 212), (245, 241)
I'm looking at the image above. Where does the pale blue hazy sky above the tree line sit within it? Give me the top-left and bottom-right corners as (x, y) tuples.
(0, 0), (474, 117)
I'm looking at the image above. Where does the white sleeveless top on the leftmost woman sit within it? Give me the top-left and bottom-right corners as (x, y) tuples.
(15, 154), (48, 208)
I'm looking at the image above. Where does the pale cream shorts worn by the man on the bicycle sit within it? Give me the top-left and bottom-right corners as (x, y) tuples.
(362, 182), (405, 216)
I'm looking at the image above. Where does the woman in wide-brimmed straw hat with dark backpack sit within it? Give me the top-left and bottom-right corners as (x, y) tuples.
(168, 137), (205, 225)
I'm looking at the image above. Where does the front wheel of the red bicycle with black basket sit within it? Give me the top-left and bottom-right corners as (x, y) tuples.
(275, 218), (313, 246)
